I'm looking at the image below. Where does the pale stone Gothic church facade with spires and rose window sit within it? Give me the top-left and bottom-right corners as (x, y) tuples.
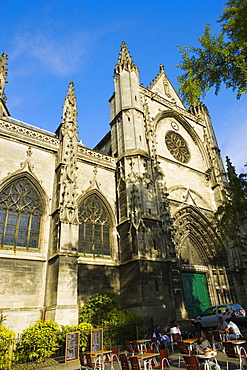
(0, 42), (241, 331)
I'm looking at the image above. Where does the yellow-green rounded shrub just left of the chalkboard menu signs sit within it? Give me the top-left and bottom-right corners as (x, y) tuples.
(16, 320), (59, 362)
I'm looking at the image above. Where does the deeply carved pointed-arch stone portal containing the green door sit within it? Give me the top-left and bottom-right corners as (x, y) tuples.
(174, 205), (230, 319)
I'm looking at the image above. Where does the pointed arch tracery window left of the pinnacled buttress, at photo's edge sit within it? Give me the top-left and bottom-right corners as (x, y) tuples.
(0, 178), (43, 251)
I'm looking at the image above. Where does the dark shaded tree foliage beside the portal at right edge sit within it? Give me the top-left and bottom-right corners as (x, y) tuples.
(216, 157), (247, 241)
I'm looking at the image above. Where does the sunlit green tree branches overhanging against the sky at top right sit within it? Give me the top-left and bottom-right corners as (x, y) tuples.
(177, 0), (247, 105)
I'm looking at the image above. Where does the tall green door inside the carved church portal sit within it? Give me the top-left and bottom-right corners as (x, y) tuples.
(181, 272), (211, 319)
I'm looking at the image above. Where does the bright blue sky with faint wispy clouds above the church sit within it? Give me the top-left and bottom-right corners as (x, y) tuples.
(0, 0), (247, 172)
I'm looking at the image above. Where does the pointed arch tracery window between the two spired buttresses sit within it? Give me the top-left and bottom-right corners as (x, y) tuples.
(78, 194), (111, 257)
